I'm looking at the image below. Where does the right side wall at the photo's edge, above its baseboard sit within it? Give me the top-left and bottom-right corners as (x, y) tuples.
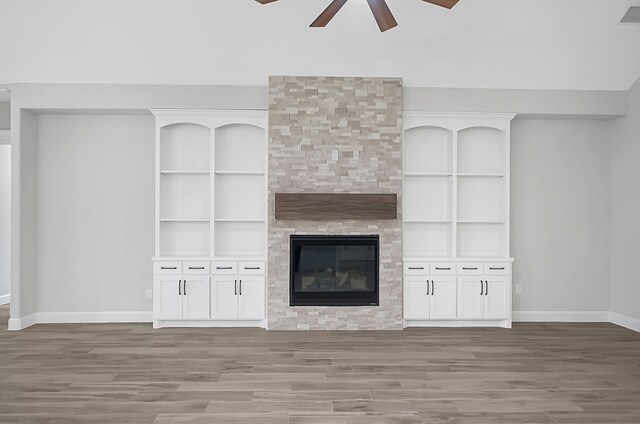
(609, 80), (640, 331)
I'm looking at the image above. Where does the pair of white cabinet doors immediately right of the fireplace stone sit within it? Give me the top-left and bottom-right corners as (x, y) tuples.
(404, 275), (456, 320)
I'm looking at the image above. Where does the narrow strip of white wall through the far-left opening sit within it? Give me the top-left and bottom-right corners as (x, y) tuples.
(0, 144), (11, 303)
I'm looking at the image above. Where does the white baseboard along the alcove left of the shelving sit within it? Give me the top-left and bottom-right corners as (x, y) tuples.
(8, 311), (153, 330)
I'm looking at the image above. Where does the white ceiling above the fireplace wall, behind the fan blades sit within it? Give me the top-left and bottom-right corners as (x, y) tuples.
(0, 0), (640, 90)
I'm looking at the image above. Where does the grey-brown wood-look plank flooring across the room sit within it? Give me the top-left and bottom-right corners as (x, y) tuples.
(0, 306), (640, 424)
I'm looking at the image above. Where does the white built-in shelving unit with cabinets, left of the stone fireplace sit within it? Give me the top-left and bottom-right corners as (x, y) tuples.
(152, 110), (267, 327)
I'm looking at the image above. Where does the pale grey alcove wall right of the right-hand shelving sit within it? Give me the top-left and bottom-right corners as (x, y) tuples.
(511, 118), (610, 319)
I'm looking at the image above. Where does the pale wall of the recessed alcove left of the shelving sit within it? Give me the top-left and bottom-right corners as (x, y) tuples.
(37, 114), (155, 313)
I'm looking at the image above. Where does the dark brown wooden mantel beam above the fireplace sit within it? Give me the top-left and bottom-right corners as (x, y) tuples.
(275, 193), (398, 220)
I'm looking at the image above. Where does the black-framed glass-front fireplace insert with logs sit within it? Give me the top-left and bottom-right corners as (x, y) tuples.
(289, 235), (380, 306)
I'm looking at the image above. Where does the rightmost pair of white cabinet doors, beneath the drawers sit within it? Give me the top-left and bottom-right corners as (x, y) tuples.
(458, 276), (511, 320)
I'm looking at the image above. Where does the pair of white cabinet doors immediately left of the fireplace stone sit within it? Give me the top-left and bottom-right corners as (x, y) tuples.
(211, 275), (265, 320)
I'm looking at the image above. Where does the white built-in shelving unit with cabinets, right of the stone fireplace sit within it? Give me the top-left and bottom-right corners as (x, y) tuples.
(403, 113), (514, 326)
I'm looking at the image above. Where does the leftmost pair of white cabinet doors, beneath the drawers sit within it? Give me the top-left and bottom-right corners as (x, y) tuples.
(154, 275), (209, 320)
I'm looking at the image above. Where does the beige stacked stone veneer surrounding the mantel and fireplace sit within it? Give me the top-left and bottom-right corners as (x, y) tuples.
(268, 77), (402, 330)
